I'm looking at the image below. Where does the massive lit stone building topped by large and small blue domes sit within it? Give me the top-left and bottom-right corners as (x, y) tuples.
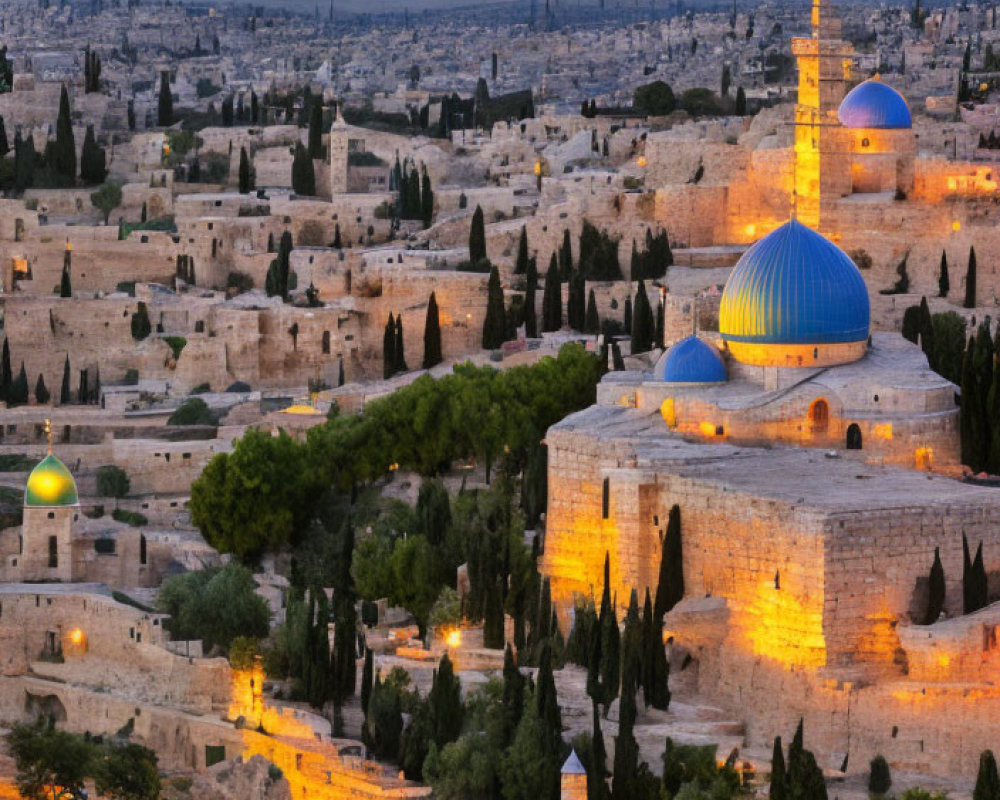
(541, 220), (1000, 774)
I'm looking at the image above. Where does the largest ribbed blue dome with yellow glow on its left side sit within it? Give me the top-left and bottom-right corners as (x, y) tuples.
(719, 219), (871, 345)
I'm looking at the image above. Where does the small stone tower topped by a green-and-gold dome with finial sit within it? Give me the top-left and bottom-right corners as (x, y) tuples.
(17, 420), (80, 583)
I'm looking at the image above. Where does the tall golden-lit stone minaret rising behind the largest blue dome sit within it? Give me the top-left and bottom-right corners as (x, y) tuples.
(792, 0), (854, 234)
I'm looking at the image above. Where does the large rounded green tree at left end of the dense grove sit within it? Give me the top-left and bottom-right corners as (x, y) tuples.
(191, 430), (322, 558)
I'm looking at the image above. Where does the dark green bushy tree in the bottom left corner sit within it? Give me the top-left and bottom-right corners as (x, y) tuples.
(5, 720), (95, 800)
